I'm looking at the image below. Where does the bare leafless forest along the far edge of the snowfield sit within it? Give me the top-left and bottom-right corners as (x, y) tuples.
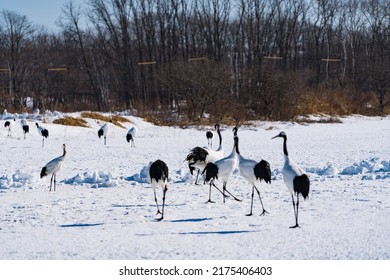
(0, 0), (390, 123)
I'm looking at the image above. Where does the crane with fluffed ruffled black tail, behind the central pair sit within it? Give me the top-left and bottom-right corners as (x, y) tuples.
(186, 124), (223, 185)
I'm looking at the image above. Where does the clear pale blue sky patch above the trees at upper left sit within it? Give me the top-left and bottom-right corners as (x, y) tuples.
(0, 0), (87, 31)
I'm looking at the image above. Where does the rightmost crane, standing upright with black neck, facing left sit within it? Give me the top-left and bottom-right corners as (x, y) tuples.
(272, 131), (310, 228)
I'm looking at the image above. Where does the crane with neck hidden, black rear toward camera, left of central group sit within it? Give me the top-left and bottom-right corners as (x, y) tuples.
(148, 159), (168, 221)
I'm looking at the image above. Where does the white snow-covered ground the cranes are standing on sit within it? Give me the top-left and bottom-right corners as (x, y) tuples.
(0, 112), (390, 260)
